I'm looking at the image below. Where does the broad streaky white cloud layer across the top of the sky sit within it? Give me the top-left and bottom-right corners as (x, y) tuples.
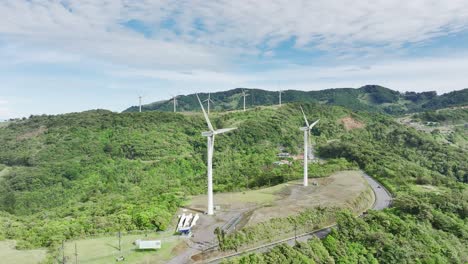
(0, 0), (468, 65)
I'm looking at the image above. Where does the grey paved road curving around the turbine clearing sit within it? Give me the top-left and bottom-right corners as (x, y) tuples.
(205, 174), (392, 263)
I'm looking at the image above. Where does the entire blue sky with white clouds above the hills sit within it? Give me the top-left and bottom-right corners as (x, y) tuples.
(0, 0), (468, 120)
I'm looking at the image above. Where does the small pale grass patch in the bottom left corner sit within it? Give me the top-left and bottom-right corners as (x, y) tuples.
(0, 240), (47, 264)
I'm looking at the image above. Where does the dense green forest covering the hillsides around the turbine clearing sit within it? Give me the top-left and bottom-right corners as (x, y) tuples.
(0, 100), (468, 263)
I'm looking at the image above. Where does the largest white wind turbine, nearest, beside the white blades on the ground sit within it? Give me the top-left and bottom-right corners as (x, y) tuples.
(197, 94), (236, 215)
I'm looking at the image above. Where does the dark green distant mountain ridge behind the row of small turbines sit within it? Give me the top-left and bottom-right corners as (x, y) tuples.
(124, 85), (468, 115)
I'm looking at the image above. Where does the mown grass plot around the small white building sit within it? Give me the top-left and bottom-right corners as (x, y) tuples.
(65, 232), (182, 264)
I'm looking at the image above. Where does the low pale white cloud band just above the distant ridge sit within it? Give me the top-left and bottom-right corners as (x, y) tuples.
(112, 56), (468, 93)
